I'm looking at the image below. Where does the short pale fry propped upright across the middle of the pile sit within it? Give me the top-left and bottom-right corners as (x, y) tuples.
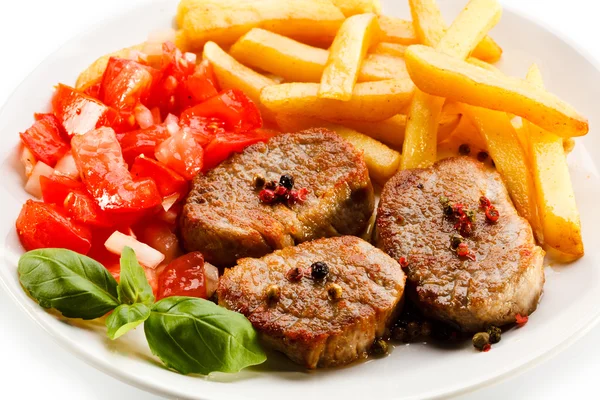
(319, 14), (379, 101)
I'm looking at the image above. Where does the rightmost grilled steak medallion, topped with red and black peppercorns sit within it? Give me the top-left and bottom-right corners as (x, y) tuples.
(376, 157), (544, 332)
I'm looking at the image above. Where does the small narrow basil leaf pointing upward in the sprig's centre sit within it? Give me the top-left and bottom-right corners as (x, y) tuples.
(117, 247), (154, 305)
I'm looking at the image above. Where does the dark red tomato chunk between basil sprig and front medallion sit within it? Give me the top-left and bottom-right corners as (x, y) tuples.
(156, 251), (206, 300)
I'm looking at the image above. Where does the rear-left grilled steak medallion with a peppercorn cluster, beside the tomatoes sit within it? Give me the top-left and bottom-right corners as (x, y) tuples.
(181, 129), (375, 266)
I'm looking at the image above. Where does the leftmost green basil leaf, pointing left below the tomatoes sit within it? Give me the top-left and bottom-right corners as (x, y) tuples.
(18, 249), (119, 319)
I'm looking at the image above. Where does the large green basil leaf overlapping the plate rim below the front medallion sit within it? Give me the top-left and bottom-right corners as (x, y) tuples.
(144, 297), (267, 375)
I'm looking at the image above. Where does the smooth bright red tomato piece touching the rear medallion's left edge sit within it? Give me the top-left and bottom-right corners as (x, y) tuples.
(131, 155), (189, 198)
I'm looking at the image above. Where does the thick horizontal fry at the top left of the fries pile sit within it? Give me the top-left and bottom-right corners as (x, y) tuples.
(180, 0), (344, 49)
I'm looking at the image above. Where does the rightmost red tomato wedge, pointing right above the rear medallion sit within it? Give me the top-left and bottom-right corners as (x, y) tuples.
(203, 131), (272, 171)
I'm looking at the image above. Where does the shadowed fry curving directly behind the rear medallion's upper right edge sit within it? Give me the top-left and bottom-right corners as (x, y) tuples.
(277, 114), (401, 185)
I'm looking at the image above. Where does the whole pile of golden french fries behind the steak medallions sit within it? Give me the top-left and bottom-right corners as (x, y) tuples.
(78, 0), (588, 260)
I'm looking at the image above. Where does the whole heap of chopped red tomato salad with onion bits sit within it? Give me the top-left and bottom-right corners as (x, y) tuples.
(16, 42), (275, 299)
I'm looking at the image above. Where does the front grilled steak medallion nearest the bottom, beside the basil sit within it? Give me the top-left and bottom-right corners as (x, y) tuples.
(217, 236), (406, 368)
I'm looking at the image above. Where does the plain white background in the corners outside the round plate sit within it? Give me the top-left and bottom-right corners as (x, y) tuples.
(0, 0), (600, 400)
